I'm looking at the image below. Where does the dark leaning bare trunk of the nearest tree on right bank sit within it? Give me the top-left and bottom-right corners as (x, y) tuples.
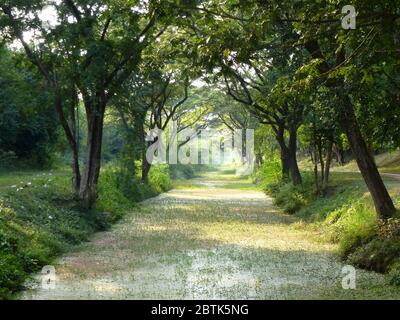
(341, 95), (396, 219)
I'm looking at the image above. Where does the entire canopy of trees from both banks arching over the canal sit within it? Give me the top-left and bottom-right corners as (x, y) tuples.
(0, 0), (400, 219)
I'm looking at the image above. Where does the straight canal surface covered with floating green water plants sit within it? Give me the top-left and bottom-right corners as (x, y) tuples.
(22, 173), (394, 299)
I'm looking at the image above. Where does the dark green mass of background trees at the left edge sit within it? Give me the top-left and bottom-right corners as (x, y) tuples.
(0, 46), (58, 167)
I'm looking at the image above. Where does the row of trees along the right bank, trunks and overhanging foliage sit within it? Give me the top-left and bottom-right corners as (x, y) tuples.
(174, 0), (400, 219)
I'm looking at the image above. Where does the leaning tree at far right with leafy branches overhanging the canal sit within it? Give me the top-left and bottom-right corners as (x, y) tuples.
(177, 0), (399, 219)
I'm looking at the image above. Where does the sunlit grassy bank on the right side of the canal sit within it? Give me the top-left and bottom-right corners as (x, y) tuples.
(257, 162), (400, 284)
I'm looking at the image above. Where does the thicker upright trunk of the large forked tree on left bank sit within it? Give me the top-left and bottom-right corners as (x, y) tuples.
(79, 103), (105, 209)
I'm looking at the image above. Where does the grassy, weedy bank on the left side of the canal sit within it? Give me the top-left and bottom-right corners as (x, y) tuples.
(0, 166), (171, 299)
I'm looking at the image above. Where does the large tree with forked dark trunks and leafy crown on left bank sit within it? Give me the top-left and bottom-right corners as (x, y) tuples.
(0, 0), (177, 208)
